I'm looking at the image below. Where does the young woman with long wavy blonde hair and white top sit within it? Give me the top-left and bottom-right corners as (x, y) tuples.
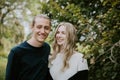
(49, 22), (88, 80)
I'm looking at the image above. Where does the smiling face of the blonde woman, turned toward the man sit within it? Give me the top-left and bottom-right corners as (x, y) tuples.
(56, 26), (67, 46)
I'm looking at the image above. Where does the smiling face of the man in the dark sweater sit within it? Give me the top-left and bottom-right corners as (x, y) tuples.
(32, 17), (51, 43)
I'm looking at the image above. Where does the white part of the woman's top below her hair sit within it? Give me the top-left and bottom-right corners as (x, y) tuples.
(49, 52), (88, 80)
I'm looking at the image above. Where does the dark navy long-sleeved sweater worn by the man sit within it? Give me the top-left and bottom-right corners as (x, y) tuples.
(5, 41), (50, 80)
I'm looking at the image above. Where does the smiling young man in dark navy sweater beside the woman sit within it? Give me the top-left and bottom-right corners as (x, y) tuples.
(5, 15), (51, 80)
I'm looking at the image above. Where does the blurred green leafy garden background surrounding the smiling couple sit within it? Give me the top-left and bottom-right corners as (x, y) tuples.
(0, 0), (120, 80)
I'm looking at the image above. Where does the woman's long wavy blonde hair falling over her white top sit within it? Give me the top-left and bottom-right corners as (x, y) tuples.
(50, 22), (77, 71)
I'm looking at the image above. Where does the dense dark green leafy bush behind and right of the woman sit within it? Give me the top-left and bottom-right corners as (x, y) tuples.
(42, 0), (120, 80)
